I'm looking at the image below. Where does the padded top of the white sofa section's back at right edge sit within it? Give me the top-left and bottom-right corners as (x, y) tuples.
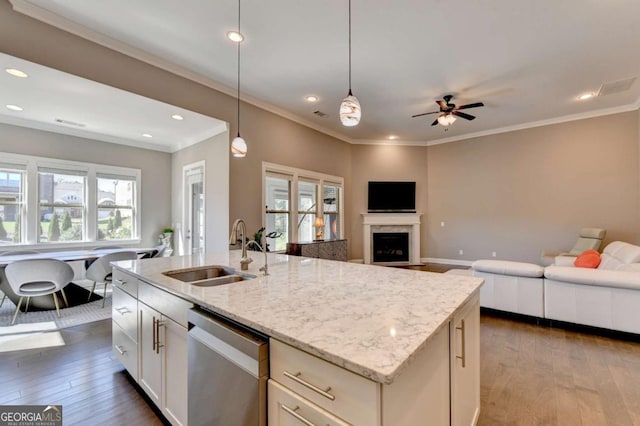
(544, 266), (640, 290)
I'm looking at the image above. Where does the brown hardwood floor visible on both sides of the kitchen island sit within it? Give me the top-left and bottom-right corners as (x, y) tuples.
(0, 315), (640, 426)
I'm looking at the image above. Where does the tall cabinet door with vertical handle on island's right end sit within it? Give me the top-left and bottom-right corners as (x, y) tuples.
(450, 296), (480, 426)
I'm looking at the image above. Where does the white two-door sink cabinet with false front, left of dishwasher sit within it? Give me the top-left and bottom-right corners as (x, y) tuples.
(138, 281), (193, 425)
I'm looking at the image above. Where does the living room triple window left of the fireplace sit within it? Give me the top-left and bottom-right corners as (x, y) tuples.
(262, 163), (344, 251)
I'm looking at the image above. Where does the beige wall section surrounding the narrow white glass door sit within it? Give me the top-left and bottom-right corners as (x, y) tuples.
(171, 132), (229, 254)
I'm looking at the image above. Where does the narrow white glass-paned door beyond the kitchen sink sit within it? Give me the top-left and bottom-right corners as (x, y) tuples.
(183, 161), (205, 255)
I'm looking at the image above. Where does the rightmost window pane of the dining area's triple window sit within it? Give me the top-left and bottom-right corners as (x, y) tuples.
(96, 175), (135, 240)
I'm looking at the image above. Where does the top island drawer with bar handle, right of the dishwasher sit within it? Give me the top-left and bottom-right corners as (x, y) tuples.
(269, 339), (380, 425)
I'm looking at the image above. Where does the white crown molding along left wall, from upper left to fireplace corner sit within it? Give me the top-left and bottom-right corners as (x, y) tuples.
(9, 0), (353, 143)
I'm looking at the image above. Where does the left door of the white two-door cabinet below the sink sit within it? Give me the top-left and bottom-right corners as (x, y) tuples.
(138, 302), (162, 407)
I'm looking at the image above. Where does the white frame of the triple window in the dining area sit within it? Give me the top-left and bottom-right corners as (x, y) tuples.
(0, 152), (142, 250)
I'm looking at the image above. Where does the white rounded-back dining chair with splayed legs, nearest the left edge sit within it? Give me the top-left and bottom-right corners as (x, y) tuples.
(5, 259), (73, 325)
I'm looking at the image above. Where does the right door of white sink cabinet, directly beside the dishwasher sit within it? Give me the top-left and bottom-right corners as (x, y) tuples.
(160, 316), (188, 425)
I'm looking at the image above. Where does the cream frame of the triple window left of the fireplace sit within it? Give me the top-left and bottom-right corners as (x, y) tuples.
(262, 161), (344, 250)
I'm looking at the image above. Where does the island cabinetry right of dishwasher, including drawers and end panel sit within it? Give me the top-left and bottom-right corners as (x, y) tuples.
(269, 294), (480, 426)
